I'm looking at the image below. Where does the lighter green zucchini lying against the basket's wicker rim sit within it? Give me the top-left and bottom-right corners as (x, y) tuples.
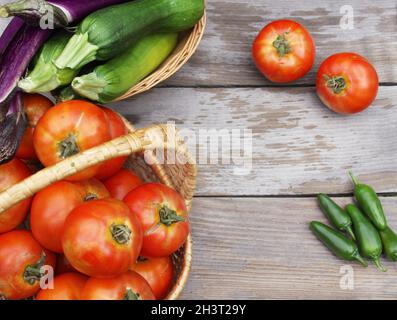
(72, 33), (178, 103)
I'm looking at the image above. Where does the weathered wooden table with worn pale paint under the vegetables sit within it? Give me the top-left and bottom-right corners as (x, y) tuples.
(3, 0), (397, 299)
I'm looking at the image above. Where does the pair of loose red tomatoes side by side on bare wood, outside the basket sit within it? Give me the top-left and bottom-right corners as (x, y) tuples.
(252, 20), (379, 114)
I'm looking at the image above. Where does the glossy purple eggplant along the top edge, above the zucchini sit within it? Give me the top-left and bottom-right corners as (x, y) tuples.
(0, 0), (126, 27)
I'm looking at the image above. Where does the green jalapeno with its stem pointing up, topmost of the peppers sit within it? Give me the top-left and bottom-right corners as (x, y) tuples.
(349, 172), (387, 230)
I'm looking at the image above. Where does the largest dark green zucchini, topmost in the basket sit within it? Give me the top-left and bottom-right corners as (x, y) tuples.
(55, 0), (204, 69)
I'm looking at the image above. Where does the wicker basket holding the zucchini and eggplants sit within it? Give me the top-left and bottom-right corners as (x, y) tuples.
(114, 12), (206, 101)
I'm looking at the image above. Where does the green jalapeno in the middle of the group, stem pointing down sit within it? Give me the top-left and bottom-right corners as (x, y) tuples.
(346, 204), (387, 271)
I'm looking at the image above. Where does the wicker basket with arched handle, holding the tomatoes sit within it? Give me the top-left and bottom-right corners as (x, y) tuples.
(0, 121), (197, 300)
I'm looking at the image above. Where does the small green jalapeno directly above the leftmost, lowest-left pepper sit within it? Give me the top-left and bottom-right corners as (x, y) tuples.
(317, 193), (356, 240)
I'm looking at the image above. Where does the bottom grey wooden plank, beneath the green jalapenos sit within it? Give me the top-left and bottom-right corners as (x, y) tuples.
(182, 198), (397, 299)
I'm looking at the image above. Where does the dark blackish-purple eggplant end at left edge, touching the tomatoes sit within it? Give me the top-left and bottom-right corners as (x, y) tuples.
(0, 92), (27, 164)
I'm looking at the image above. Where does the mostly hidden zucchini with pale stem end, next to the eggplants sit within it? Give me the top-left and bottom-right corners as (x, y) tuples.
(18, 30), (78, 93)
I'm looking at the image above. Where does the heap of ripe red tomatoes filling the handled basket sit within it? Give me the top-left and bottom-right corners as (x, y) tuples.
(0, 95), (189, 300)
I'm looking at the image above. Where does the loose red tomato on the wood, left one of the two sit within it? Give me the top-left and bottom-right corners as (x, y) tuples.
(252, 20), (316, 83)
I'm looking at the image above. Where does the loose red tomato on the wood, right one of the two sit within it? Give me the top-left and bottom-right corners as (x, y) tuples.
(316, 53), (379, 114)
